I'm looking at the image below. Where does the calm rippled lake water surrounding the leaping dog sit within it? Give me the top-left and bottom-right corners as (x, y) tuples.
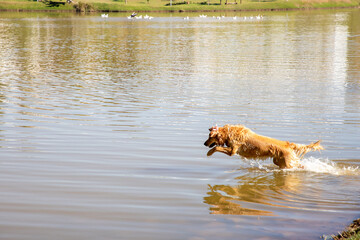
(0, 9), (360, 240)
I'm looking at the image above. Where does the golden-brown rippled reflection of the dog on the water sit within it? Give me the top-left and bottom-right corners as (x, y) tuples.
(204, 171), (301, 216)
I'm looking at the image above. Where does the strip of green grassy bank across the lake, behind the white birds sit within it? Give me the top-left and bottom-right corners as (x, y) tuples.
(0, 0), (360, 12)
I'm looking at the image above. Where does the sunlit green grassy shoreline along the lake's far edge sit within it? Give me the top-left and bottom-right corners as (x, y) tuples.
(0, 0), (360, 13)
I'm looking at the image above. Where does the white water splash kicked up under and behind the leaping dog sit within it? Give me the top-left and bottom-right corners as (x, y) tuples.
(241, 157), (360, 175)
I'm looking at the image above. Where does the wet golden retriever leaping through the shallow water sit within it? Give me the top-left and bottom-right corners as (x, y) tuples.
(204, 125), (324, 169)
